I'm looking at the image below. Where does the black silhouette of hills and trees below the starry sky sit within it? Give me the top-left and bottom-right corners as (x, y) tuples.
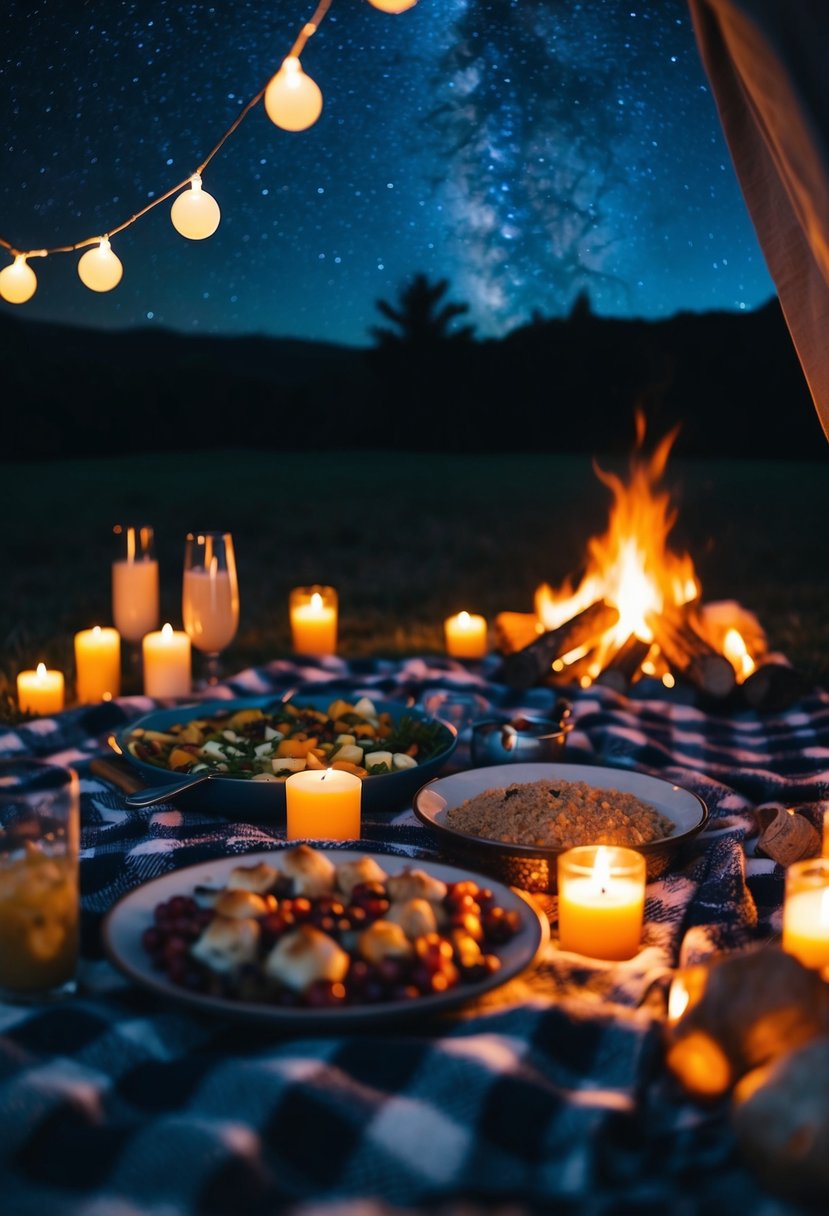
(0, 300), (829, 460)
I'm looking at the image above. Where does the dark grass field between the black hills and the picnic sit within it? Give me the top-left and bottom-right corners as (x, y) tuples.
(0, 445), (829, 714)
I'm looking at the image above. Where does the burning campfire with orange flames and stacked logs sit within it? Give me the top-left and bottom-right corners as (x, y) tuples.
(495, 412), (803, 709)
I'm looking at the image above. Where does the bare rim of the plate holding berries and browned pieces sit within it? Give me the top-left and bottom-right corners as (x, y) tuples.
(101, 845), (549, 1032)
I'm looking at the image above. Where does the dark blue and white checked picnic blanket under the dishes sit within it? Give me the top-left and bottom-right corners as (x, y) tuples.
(0, 658), (829, 1216)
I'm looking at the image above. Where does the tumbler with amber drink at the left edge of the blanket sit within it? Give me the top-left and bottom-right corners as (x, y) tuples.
(0, 758), (80, 1003)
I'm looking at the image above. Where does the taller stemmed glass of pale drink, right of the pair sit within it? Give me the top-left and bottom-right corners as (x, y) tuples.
(181, 531), (239, 685)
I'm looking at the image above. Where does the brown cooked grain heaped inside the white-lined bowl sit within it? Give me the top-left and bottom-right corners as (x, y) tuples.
(446, 778), (675, 849)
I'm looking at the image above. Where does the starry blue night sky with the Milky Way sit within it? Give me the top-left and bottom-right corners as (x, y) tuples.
(0, 0), (774, 347)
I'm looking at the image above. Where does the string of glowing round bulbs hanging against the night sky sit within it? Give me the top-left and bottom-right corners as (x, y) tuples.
(0, 0), (417, 304)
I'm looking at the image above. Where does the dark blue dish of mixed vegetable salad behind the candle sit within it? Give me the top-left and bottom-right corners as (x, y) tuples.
(114, 688), (458, 823)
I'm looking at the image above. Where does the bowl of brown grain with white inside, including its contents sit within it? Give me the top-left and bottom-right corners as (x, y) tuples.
(412, 764), (709, 893)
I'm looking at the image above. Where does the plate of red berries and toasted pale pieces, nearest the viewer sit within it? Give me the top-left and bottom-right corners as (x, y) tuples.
(102, 844), (549, 1031)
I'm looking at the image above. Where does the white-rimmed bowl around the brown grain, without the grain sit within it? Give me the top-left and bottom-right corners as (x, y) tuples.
(412, 764), (709, 893)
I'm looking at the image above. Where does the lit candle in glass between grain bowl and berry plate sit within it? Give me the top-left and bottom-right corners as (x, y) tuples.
(558, 845), (645, 959)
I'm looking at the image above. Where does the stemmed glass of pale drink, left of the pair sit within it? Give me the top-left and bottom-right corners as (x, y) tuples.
(112, 524), (159, 687)
